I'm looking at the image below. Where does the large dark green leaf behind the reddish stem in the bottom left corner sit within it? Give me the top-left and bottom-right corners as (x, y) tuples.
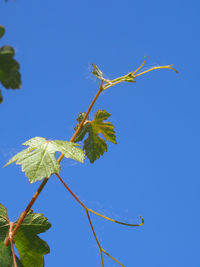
(0, 204), (51, 267)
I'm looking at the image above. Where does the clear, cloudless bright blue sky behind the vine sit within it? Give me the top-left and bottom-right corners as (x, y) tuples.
(0, 0), (200, 267)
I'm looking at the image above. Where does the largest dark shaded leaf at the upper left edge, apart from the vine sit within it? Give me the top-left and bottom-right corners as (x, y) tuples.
(0, 46), (21, 89)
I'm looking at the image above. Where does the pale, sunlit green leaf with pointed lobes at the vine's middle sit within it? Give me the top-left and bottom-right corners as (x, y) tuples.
(5, 137), (85, 183)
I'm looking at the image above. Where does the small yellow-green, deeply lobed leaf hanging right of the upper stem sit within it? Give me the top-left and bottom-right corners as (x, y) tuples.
(75, 110), (117, 163)
